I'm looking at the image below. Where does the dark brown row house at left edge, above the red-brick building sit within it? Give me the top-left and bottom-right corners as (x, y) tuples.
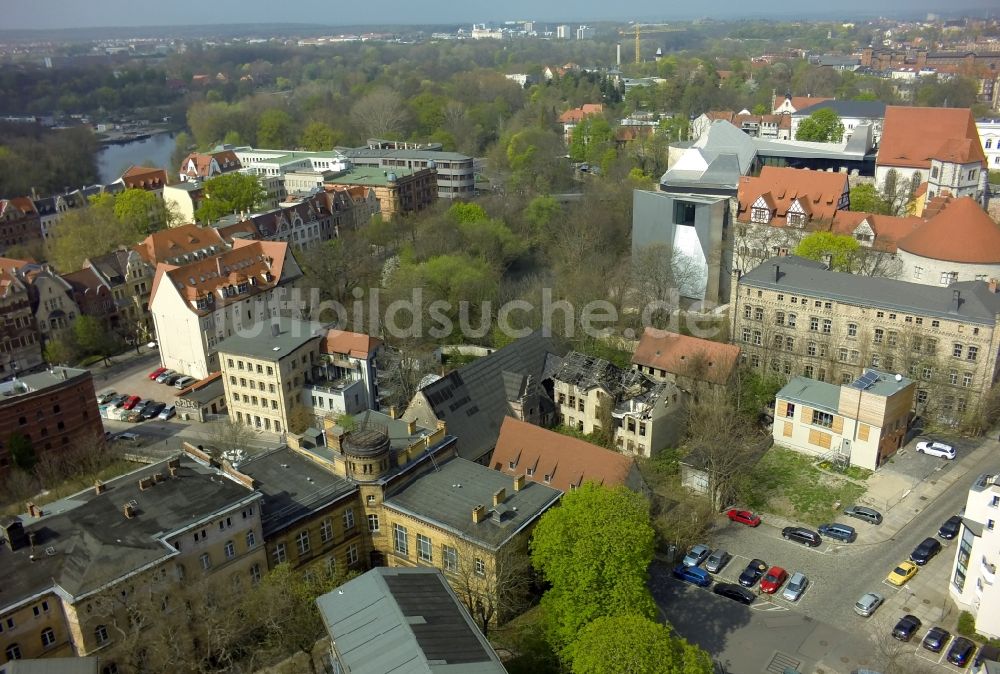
(0, 258), (42, 380)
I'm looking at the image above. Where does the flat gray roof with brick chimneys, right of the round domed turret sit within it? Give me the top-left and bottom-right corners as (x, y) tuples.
(385, 457), (562, 556)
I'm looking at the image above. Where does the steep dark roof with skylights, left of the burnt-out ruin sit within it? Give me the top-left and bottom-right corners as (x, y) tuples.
(410, 331), (555, 460)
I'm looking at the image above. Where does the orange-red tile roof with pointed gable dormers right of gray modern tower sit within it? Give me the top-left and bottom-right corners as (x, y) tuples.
(737, 166), (848, 227)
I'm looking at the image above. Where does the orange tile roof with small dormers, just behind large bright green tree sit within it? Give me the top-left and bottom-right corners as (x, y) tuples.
(490, 417), (641, 492)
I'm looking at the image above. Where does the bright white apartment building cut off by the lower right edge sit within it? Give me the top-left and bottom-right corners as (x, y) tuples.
(948, 473), (1000, 639)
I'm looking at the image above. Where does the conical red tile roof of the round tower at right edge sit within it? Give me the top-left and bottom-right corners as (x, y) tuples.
(899, 197), (1000, 264)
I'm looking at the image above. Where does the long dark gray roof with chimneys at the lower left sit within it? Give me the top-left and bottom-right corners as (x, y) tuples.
(0, 458), (259, 606)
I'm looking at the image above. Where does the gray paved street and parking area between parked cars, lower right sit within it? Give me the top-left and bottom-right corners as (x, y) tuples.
(651, 438), (997, 674)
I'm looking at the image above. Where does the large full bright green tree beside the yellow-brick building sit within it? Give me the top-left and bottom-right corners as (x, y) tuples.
(531, 482), (656, 661)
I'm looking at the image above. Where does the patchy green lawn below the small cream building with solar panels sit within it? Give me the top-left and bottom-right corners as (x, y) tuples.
(743, 447), (865, 525)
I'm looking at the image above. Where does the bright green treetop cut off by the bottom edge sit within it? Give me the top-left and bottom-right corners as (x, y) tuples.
(572, 615), (715, 674)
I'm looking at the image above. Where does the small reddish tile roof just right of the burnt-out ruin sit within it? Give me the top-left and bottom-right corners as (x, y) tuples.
(632, 328), (740, 384)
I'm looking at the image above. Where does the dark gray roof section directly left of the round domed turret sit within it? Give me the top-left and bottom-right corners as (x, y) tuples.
(239, 448), (357, 539)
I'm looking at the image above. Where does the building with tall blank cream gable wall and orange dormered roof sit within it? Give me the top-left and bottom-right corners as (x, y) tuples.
(149, 239), (302, 379)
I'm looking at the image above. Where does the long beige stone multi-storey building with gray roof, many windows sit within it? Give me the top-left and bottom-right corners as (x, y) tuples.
(730, 256), (1000, 423)
